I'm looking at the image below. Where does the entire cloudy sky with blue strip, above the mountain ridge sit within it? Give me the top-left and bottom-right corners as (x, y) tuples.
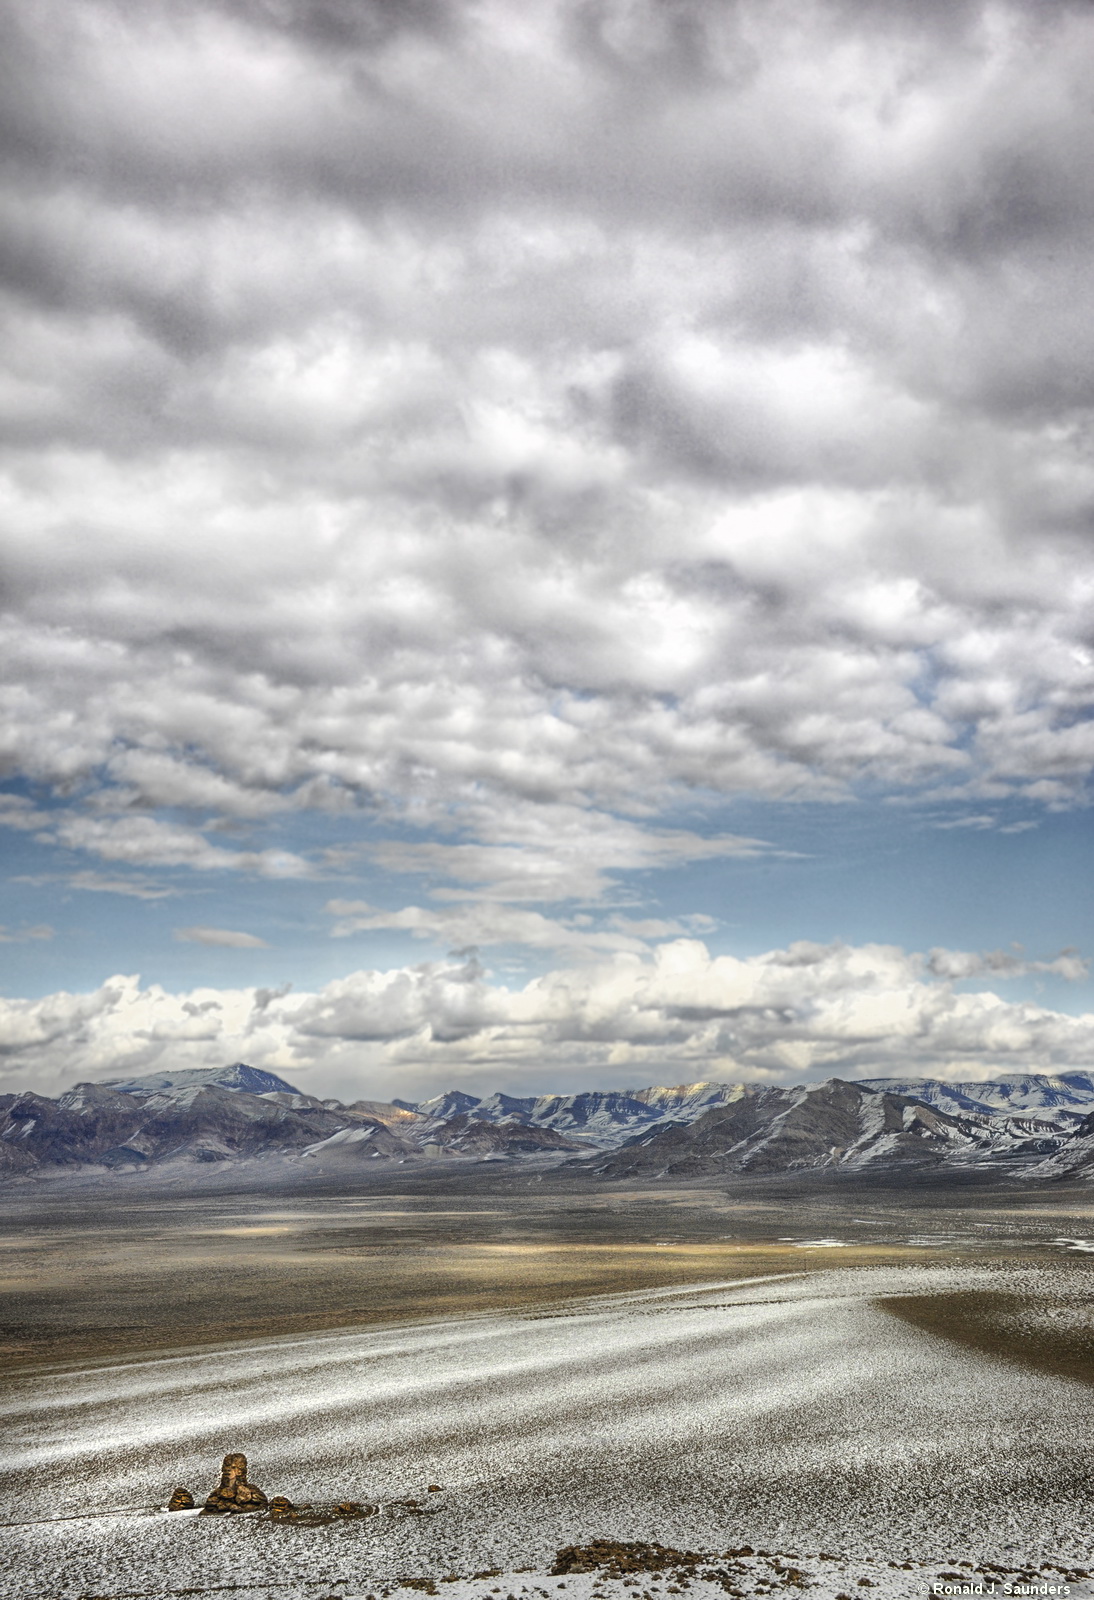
(0, 0), (1094, 1101)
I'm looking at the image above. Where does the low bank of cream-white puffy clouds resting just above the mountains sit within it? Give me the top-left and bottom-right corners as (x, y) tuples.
(0, 938), (1094, 1098)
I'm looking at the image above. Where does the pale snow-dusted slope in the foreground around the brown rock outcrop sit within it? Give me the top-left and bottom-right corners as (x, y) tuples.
(0, 1266), (1094, 1600)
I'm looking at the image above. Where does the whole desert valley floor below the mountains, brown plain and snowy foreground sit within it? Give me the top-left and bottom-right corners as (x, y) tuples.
(0, 1173), (1094, 1600)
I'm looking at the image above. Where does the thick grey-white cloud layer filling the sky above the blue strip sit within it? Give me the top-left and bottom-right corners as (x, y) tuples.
(0, 0), (1094, 870)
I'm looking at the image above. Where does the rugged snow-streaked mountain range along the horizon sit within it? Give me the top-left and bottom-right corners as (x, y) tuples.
(0, 1062), (1094, 1181)
